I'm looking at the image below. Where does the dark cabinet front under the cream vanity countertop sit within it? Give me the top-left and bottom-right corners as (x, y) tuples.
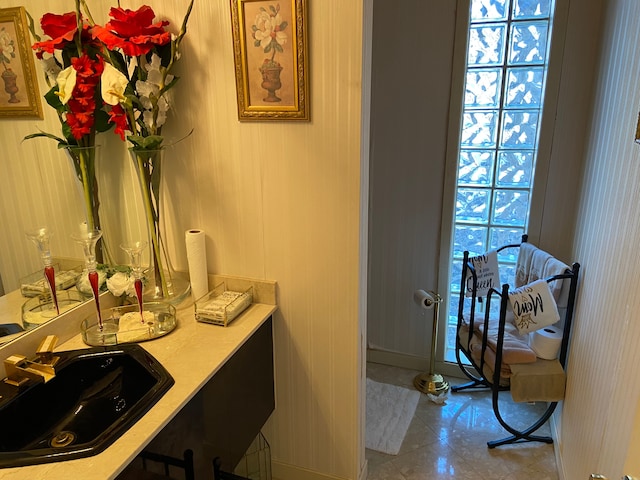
(117, 317), (275, 480)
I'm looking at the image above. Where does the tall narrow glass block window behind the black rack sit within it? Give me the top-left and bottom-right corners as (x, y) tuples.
(444, 0), (555, 361)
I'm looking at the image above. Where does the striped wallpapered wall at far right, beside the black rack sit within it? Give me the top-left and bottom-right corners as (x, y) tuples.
(558, 0), (640, 480)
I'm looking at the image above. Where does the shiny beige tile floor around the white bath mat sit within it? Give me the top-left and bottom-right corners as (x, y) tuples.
(366, 363), (558, 480)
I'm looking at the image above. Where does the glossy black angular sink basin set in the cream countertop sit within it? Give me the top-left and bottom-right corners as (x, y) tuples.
(0, 344), (174, 468)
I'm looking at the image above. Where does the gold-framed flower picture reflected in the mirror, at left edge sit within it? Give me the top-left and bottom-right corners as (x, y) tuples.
(0, 7), (43, 119)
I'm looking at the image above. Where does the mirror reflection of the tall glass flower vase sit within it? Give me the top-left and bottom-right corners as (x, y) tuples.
(64, 145), (112, 264)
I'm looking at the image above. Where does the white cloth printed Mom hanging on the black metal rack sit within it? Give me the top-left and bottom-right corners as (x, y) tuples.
(509, 280), (560, 335)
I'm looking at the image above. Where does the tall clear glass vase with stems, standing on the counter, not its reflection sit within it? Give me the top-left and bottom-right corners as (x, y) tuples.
(130, 149), (191, 305)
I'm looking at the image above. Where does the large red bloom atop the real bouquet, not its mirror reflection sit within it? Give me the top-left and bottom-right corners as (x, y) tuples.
(91, 5), (171, 57)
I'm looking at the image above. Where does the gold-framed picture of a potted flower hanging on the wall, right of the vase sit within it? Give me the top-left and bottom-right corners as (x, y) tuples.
(231, 0), (309, 121)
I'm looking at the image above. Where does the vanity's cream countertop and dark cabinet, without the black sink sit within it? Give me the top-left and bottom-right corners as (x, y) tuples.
(0, 276), (277, 480)
